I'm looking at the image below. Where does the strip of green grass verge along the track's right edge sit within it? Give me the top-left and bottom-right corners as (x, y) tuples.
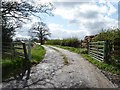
(57, 45), (120, 75)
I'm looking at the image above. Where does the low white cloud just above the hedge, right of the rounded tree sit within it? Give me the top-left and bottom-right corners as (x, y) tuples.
(48, 23), (89, 39)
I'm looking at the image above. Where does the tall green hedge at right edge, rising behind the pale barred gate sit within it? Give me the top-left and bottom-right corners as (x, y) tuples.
(93, 28), (120, 67)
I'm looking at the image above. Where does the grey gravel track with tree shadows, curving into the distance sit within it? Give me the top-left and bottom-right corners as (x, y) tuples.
(3, 46), (115, 89)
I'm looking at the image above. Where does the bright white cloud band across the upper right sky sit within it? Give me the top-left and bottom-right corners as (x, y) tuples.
(53, 2), (117, 20)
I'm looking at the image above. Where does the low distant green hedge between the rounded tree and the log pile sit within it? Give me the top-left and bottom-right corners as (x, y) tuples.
(46, 38), (80, 48)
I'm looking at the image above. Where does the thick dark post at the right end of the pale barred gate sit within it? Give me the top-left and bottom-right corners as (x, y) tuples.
(104, 40), (110, 64)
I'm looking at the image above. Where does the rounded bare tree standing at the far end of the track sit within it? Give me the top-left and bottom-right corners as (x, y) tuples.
(31, 22), (51, 45)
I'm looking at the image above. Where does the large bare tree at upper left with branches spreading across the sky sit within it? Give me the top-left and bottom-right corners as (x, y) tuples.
(1, 0), (53, 42)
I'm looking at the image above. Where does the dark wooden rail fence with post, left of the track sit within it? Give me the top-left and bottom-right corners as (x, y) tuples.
(2, 42), (28, 60)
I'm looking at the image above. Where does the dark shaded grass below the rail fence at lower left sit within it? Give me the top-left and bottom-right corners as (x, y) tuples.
(0, 58), (23, 80)
